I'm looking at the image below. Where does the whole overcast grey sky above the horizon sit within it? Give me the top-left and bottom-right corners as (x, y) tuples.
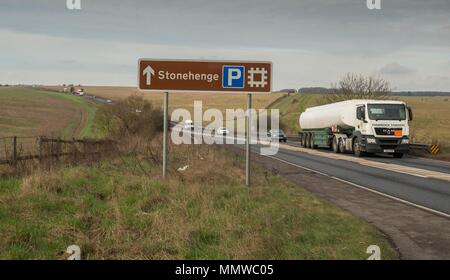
(0, 0), (450, 91)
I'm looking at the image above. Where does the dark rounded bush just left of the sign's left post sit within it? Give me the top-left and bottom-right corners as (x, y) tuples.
(98, 94), (164, 139)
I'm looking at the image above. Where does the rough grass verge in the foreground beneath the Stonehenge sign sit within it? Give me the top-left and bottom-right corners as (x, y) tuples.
(0, 142), (398, 259)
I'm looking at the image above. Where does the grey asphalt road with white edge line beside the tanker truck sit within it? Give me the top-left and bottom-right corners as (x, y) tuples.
(240, 143), (450, 217)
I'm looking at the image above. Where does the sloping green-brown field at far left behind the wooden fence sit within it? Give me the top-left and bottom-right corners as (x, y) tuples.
(0, 87), (96, 138)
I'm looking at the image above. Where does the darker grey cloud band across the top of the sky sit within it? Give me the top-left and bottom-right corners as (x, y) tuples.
(0, 0), (450, 54)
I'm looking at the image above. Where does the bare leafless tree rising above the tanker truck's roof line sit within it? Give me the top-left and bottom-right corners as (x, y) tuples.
(324, 73), (391, 103)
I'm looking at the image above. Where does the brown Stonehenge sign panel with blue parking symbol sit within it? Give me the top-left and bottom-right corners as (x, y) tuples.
(138, 59), (272, 93)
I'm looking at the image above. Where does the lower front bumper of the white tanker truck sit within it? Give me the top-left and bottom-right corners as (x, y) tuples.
(361, 137), (409, 154)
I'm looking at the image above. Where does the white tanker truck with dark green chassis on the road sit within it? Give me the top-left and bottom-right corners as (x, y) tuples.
(299, 99), (412, 158)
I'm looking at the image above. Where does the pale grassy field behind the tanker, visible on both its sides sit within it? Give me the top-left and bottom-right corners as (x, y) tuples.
(271, 94), (450, 159)
